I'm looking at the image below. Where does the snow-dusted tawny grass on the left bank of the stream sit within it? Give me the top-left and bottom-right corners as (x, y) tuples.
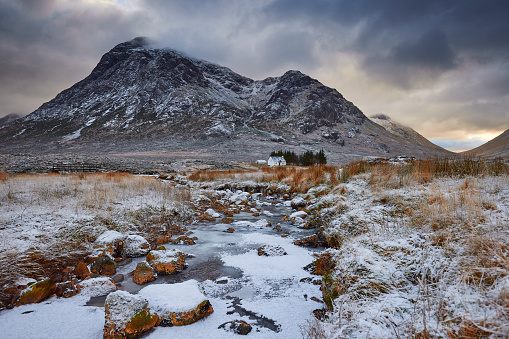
(0, 172), (192, 306)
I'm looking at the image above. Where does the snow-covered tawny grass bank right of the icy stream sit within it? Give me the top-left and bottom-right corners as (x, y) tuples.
(313, 175), (509, 338)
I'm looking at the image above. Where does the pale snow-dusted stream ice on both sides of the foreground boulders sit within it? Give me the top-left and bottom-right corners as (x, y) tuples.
(0, 201), (322, 339)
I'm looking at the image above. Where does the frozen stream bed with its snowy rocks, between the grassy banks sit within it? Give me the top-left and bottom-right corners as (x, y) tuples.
(0, 187), (323, 338)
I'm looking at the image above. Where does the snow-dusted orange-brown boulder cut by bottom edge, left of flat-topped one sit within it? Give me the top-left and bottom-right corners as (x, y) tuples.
(103, 291), (159, 339)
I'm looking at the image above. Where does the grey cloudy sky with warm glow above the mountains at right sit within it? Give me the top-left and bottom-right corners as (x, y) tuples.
(0, 0), (509, 150)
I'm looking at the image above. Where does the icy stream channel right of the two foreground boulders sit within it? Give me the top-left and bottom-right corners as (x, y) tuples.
(87, 197), (323, 338)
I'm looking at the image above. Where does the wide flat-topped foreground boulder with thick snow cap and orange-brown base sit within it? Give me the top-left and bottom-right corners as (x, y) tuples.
(138, 280), (214, 326)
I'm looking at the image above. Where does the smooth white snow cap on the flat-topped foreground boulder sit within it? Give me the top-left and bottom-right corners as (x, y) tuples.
(138, 279), (207, 315)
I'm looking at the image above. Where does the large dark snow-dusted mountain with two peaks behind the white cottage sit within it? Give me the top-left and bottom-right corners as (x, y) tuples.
(0, 38), (451, 163)
